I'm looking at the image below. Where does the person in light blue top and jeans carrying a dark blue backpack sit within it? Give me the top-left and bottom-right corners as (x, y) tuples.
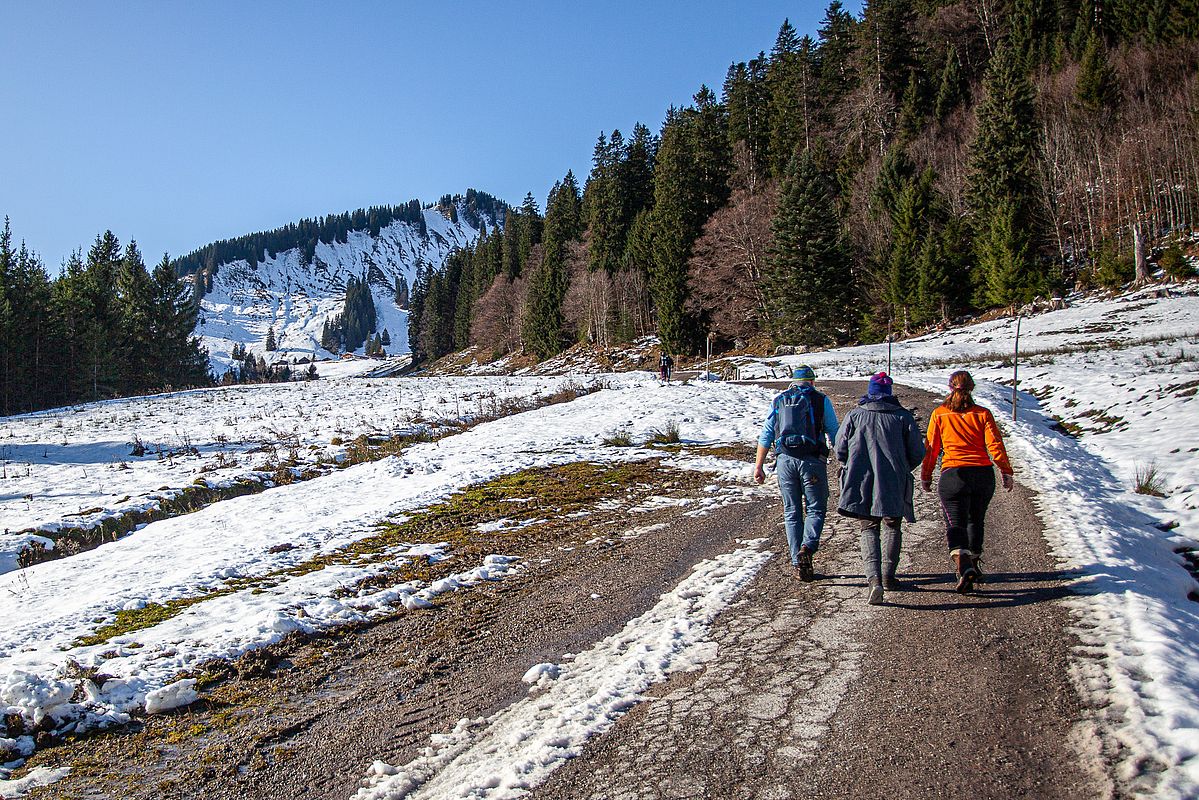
(753, 365), (837, 581)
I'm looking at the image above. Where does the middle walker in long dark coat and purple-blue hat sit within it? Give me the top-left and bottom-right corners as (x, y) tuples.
(836, 372), (924, 606)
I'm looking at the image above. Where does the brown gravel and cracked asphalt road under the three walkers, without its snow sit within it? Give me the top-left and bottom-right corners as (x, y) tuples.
(23, 383), (1114, 800)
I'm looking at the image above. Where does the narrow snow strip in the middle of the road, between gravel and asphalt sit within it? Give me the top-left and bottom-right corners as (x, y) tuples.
(355, 542), (770, 800)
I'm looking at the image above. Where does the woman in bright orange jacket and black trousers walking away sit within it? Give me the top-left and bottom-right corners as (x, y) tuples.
(920, 371), (1013, 594)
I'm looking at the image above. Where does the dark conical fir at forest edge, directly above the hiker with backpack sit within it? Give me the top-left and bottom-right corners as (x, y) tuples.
(765, 151), (852, 347)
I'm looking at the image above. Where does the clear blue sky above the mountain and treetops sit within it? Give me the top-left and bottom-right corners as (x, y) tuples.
(0, 0), (861, 273)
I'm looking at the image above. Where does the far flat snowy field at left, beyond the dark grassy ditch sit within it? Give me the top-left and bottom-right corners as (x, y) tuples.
(0, 369), (602, 575)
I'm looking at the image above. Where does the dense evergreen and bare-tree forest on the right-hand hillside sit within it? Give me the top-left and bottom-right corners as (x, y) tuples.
(409, 0), (1199, 360)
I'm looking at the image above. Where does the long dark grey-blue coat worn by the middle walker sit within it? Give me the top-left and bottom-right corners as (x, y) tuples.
(835, 396), (924, 522)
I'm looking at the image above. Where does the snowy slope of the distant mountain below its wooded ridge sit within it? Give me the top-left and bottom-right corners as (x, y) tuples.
(195, 199), (500, 375)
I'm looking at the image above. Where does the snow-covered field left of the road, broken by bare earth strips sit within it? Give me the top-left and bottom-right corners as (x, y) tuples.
(0, 374), (769, 792)
